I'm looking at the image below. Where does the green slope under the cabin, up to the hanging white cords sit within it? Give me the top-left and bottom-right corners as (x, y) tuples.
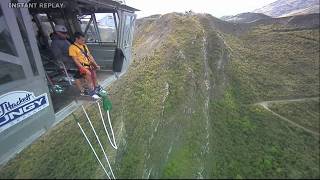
(0, 104), (115, 179)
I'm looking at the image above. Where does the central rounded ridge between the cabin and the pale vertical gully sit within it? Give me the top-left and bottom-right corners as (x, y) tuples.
(112, 14), (218, 178)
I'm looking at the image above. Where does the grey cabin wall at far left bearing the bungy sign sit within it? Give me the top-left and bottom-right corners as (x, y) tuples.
(0, 0), (55, 164)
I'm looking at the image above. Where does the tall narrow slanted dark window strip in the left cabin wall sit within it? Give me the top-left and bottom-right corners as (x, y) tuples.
(14, 8), (39, 76)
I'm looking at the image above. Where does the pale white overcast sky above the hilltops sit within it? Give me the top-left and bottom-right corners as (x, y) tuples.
(125, 0), (276, 18)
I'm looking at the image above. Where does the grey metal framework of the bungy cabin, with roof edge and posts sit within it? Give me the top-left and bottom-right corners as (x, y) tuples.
(0, 0), (138, 165)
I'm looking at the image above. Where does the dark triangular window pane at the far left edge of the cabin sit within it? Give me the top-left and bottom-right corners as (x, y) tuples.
(0, 6), (17, 56)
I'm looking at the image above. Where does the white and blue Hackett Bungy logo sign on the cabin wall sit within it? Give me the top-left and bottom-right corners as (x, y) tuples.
(0, 91), (49, 132)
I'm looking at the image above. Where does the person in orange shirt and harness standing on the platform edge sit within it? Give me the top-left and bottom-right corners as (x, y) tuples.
(69, 32), (102, 99)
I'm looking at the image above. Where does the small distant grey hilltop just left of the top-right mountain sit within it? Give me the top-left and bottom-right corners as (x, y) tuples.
(220, 12), (271, 23)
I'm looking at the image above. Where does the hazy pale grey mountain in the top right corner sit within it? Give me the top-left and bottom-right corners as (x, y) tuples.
(253, 0), (319, 17)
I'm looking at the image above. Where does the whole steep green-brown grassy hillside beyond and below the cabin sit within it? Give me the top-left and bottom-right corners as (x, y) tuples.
(0, 13), (320, 178)
